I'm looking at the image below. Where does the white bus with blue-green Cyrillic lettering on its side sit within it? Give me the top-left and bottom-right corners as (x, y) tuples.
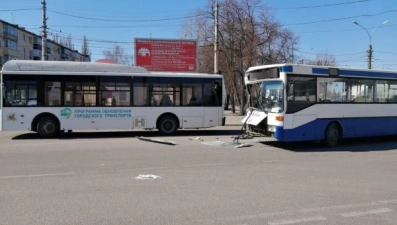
(0, 60), (225, 137)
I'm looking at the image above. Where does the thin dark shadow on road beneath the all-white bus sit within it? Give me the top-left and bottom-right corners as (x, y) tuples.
(12, 129), (241, 140)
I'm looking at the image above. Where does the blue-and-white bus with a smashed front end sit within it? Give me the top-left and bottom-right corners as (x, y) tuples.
(243, 64), (397, 146)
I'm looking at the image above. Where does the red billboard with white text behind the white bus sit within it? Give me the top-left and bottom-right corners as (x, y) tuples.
(135, 38), (197, 72)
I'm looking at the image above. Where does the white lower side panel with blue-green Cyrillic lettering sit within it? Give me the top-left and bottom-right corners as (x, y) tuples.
(3, 107), (223, 131)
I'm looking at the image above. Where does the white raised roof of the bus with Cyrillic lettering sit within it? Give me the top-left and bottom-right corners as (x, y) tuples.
(2, 60), (223, 78)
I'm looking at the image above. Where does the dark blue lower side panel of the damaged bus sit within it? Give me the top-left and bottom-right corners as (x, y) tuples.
(274, 117), (397, 141)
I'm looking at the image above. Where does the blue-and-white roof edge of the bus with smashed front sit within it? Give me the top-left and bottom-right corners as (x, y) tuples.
(247, 63), (397, 79)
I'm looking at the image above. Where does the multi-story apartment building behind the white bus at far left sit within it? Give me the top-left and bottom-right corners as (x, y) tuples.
(0, 20), (91, 68)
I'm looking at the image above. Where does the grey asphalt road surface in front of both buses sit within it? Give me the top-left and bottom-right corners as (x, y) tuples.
(0, 126), (397, 225)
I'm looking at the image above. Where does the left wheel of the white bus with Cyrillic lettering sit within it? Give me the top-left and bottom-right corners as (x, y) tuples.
(31, 113), (60, 138)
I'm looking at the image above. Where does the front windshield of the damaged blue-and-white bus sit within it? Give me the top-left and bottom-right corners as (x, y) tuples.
(249, 81), (284, 113)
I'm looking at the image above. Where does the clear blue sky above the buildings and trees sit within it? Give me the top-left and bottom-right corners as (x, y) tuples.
(0, 0), (397, 70)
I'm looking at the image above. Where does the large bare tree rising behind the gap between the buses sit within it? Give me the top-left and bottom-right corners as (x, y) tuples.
(182, 0), (298, 114)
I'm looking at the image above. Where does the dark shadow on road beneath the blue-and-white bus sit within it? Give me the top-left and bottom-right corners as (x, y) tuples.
(261, 136), (397, 152)
